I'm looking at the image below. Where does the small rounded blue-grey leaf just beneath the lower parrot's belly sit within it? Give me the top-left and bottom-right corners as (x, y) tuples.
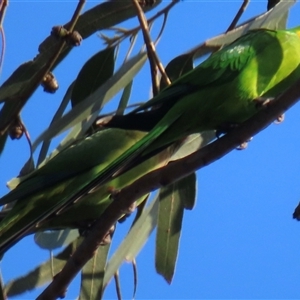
(34, 229), (79, 250)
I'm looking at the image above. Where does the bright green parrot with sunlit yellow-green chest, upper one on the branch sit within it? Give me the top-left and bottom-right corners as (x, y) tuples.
(74, 26), (300, 191)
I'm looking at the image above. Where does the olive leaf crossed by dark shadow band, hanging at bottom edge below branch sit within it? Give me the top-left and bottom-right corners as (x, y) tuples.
(79, 244), (110, 300)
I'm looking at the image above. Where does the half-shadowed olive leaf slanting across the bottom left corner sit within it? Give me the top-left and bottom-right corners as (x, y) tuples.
(5, 238), (82, 297)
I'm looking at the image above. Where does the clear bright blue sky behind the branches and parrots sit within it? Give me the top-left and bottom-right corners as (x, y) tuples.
(0, 1), (300, 299)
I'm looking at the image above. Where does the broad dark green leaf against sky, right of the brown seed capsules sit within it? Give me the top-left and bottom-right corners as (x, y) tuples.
(71, 47), (115, 107)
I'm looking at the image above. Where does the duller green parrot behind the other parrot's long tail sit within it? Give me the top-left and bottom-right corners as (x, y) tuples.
(0, 128), (176, 253)
